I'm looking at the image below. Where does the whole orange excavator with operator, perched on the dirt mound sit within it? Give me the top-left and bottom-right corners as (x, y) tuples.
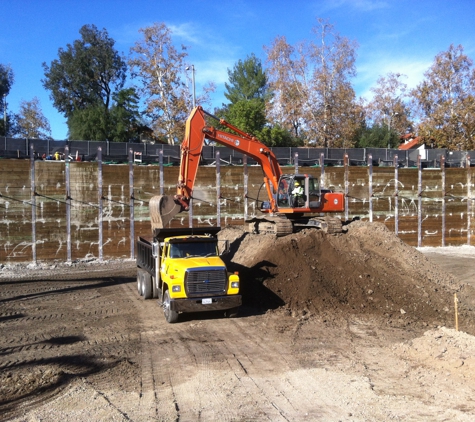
(149, 106), (345, 236)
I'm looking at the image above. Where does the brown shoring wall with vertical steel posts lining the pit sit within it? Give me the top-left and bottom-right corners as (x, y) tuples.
(0, 152), (474, 263)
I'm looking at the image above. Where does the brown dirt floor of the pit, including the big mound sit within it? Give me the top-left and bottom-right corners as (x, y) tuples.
(0, 222), (475, 421)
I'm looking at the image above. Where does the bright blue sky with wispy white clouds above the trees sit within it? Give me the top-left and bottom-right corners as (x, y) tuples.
(0, 0), (475, 140)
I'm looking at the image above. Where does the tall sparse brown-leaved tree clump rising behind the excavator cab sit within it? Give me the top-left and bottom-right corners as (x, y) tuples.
(265, 19), (361, 147)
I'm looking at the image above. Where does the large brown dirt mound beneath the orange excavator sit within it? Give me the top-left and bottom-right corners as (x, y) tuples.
(221, 221), (475, 332)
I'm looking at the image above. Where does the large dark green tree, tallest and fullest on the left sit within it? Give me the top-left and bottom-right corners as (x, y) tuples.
(42, 25), (127, 140)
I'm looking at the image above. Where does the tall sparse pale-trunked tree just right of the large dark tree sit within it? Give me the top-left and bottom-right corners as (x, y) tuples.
(129, 23), (214, 144)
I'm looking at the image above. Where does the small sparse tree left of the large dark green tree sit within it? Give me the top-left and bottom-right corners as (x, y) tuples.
(17, 97), (51, 139)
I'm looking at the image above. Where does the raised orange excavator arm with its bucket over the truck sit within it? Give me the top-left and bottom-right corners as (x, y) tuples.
(149, 106), (282, 229)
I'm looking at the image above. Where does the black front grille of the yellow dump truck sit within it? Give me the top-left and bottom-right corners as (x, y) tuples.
(185, 268), (226, 297)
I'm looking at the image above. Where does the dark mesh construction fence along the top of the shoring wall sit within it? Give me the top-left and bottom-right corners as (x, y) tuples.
(0, 137), (475, 168)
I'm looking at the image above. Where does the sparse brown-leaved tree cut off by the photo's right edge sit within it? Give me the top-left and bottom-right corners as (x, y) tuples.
(411, 45), (475, 149)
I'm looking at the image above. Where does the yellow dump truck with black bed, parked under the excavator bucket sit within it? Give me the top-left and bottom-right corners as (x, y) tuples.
(137, 227), (241, 323)
